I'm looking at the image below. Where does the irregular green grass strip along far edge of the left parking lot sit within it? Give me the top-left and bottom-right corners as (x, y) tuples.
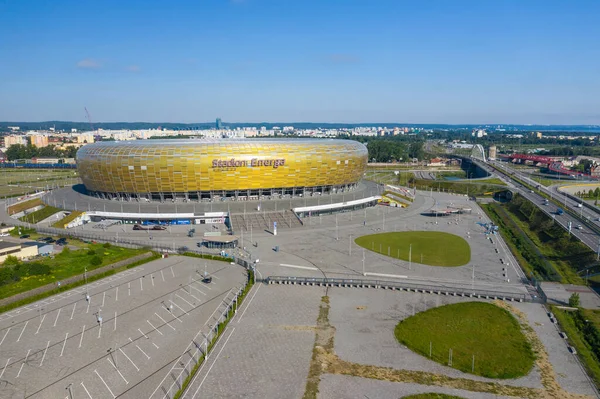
(0, 244), (148, 299)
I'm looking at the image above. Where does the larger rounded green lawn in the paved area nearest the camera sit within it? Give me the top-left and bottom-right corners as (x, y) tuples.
(394, 302), (534, 378)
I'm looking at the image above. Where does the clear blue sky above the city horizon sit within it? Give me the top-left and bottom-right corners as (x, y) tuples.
(0, 0), (600, 124)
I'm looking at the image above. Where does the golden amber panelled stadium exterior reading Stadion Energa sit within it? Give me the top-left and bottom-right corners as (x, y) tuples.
(77, 139), (368, 201)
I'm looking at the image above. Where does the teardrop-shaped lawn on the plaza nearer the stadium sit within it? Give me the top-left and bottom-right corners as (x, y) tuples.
(354, 231), (471, 266)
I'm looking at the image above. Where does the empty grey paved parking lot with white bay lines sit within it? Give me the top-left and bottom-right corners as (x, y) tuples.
(0, 256), (246, 398)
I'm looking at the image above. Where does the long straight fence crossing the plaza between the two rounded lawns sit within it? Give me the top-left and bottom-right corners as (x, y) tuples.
(264, 276), (542, 303)
